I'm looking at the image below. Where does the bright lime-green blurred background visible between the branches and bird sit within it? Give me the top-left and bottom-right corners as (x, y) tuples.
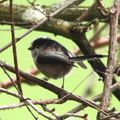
(0, 0), (120, 120)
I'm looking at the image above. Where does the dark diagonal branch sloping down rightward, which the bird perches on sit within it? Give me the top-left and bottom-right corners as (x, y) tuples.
(0, 61), (108, 115)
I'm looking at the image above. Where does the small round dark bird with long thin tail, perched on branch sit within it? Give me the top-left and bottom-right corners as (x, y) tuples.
(28, 37), (106, 86)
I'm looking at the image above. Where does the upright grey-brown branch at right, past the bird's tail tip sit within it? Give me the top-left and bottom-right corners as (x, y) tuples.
(101, 0), (120, 118)
